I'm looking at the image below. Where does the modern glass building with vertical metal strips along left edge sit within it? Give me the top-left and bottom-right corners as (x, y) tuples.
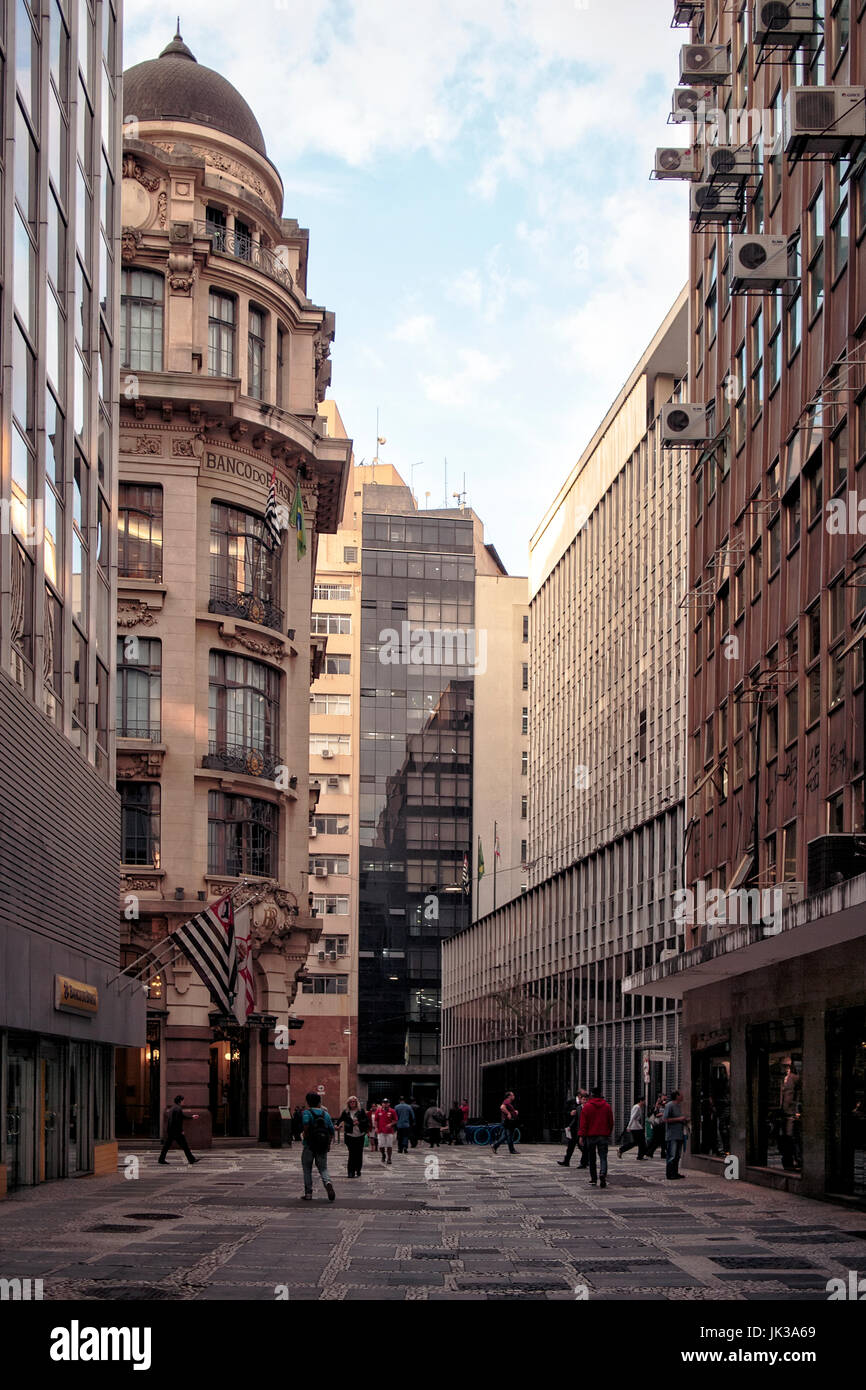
(0, 0), (145, 1195)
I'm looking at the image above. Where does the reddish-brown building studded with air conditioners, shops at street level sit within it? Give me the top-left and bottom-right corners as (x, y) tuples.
(630, 0), (866, 1202)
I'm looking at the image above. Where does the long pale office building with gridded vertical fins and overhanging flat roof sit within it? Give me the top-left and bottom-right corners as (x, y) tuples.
(442, 292), (688, 1138)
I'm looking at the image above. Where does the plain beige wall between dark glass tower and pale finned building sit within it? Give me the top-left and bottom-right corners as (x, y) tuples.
(473, 574), (530, 919)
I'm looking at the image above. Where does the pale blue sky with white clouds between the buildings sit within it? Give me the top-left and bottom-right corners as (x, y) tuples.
(124, 0), (688, 574)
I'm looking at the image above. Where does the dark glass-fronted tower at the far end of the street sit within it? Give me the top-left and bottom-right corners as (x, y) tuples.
(359, 480), (505, 1102)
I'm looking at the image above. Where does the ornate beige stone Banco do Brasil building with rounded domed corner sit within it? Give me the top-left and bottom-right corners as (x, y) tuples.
(117, 33), (350, 1147)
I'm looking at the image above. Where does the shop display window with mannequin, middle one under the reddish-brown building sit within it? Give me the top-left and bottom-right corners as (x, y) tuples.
(746, 1019), (803, 1173)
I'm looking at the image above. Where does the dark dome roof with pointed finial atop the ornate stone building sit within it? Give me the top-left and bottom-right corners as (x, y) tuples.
(124, 31), (267, 157)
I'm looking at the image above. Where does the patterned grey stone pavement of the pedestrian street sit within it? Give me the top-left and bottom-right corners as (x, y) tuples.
(0, 1145), (866, 1301)
